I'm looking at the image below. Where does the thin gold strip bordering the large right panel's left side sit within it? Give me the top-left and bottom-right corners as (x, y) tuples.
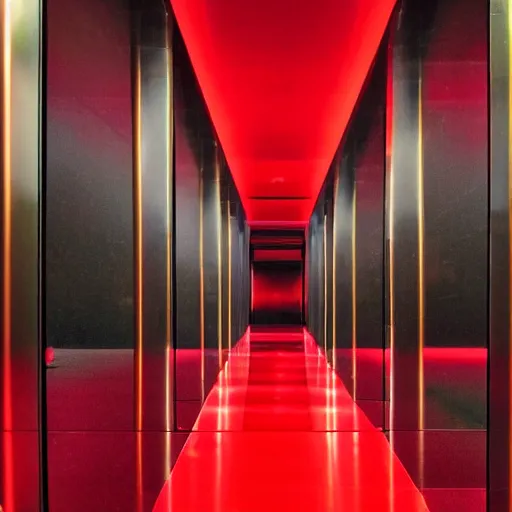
(417, 61), (425, 434)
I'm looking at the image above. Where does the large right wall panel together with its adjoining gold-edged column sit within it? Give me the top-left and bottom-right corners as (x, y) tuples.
(387, 0), (488, 430)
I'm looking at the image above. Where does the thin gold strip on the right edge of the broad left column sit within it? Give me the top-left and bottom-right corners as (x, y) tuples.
(164, 26), (174, 472)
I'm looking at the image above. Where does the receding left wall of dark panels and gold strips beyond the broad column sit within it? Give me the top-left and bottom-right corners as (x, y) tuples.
(173, 22), (249, 429)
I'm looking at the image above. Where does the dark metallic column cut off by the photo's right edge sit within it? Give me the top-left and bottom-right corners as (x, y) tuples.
(488, 0), (512, 512)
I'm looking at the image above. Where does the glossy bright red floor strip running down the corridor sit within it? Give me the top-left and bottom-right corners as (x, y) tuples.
(153, 330), (428, 512)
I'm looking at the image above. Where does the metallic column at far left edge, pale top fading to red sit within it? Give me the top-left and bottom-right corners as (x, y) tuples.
(0, 0), (44, 512)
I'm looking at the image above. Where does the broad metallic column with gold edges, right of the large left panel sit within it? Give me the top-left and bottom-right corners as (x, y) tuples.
(133, 2), (174, 431)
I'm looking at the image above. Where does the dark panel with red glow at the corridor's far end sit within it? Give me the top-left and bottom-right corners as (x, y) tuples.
(252, 261), (303, 324)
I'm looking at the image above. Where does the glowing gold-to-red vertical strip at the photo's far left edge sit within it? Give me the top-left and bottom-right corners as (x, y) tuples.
(2, 7), (12, 511)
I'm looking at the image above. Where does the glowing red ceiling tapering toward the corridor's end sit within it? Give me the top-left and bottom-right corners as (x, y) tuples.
(171, 0), (395, 222)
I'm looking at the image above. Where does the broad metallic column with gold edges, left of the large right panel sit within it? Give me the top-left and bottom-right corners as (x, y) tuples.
(387, 2), (425, 430)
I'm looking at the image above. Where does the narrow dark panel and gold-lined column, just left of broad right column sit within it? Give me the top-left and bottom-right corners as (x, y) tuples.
(331, 49), (386, 412)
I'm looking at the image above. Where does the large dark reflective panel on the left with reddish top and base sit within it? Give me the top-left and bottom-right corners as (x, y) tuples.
(45, 0), (134, 431)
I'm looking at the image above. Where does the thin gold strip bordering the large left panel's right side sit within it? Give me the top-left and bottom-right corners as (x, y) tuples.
(133, 45), (143, 431)
